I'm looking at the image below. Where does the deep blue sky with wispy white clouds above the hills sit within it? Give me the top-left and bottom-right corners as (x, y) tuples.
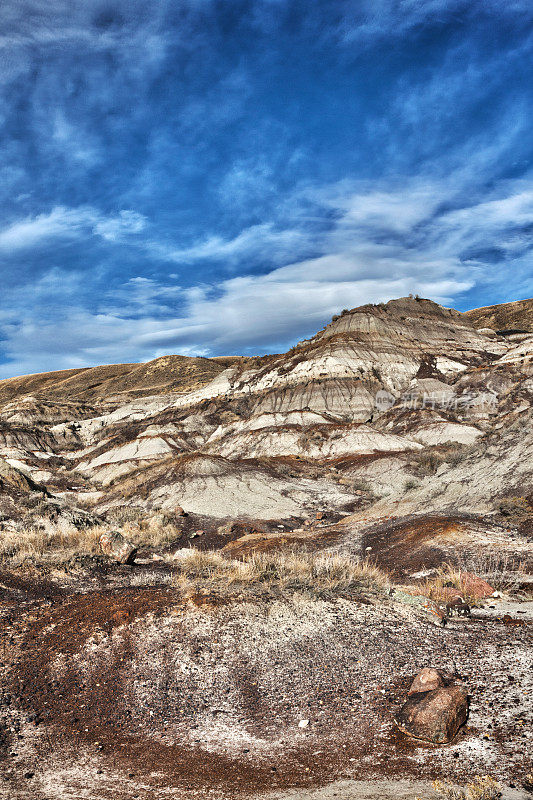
(0, 0), (533, 377)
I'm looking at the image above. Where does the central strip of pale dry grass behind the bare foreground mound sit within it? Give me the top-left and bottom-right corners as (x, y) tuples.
(172, 550), (389, 596)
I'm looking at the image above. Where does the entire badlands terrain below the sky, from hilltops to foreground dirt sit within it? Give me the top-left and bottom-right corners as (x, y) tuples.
(0, 297), (533, 800)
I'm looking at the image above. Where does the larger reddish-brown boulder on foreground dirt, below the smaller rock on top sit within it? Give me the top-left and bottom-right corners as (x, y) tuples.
(396, 686), (468, 744)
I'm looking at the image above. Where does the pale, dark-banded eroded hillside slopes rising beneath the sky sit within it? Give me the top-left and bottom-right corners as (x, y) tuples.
(0, 298), (533, 524)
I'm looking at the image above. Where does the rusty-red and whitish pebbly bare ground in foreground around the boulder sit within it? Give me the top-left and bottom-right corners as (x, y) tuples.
(0, 571), (533, 800)
